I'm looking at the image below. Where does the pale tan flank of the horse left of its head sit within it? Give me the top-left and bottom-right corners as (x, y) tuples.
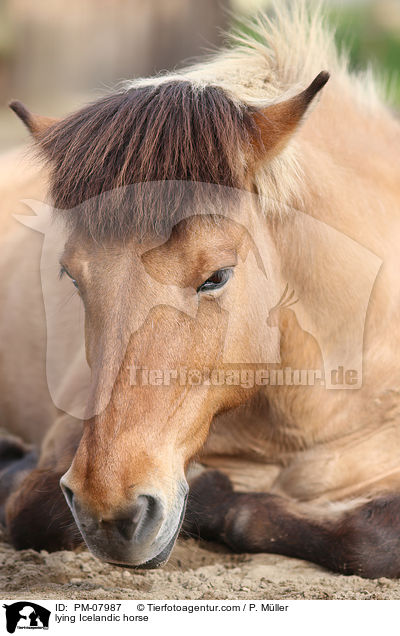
(0, 149), (57, 444)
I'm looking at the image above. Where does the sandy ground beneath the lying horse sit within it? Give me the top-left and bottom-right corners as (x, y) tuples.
(0, 535), (400, 600)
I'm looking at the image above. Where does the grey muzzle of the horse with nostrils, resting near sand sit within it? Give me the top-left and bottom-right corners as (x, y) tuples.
(60, 475), (189, 569)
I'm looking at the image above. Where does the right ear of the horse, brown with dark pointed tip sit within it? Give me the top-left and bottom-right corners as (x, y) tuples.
(253, 71), (329, 159)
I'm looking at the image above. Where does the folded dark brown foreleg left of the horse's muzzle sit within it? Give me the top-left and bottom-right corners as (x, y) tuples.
(1, 418), (83, 552)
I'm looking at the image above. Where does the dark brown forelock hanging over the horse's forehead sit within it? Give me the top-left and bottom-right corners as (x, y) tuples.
(39, 81), (256, 238)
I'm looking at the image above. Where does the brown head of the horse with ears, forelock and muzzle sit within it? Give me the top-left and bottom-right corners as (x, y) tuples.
(13, 73), (328, 567)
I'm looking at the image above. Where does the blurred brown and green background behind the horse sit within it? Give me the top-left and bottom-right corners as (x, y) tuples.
(0, 0), (400, 150)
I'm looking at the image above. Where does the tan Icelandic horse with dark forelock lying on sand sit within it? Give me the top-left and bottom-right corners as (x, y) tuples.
(0, 3), (400, 578)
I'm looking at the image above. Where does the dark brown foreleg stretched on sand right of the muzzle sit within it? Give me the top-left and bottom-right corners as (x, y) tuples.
(183, 471), (400, 578)
